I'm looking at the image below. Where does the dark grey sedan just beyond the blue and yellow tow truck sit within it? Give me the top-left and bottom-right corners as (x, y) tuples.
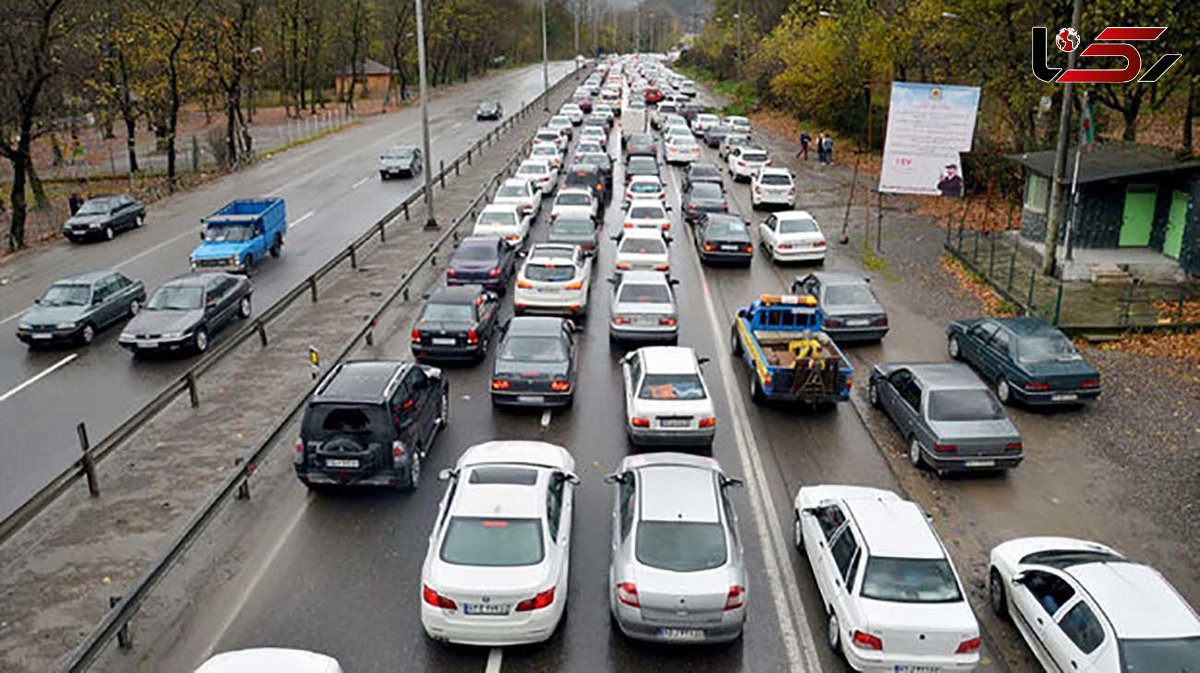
(792, 271), (888, 343)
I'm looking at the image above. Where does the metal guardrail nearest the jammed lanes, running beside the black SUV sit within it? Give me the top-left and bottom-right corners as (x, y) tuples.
(60, 66), (569, 673)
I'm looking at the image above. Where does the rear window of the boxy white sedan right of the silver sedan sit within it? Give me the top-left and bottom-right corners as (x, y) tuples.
(860, 557), (962, 603)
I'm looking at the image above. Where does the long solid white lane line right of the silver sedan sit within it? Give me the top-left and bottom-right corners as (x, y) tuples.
(667, 163), (821, 673)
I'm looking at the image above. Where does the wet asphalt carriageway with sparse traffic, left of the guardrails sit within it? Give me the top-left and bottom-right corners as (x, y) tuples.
(0, 64), (571, 518)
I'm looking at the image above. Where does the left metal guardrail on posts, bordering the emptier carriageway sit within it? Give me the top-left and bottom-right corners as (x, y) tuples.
(0, 66), (574, 543)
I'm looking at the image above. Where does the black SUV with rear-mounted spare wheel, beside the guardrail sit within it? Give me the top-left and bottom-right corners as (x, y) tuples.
(294, 360), (450, 489)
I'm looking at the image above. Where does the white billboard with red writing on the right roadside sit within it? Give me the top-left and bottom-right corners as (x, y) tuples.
(880, 82), (979, 197)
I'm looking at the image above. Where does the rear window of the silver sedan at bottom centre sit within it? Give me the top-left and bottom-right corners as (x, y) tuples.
(635, 521), (728, 572)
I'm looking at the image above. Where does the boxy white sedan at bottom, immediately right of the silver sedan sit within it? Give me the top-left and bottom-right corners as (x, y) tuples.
(793, 486), (980, 673)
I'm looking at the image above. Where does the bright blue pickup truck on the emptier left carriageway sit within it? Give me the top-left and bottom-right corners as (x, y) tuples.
(192, 197), (288, 274)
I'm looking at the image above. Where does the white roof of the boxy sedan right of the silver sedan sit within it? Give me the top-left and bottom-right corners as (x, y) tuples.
(842, 498), (946, 559)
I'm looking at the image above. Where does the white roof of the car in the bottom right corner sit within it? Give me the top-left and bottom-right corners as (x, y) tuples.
(1064, 560), (1200, 638)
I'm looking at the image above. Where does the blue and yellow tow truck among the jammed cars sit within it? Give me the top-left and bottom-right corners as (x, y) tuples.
(730, 294), (854, 407)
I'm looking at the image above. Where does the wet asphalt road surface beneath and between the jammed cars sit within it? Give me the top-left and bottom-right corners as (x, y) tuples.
(169, 112), (1003, 673)
